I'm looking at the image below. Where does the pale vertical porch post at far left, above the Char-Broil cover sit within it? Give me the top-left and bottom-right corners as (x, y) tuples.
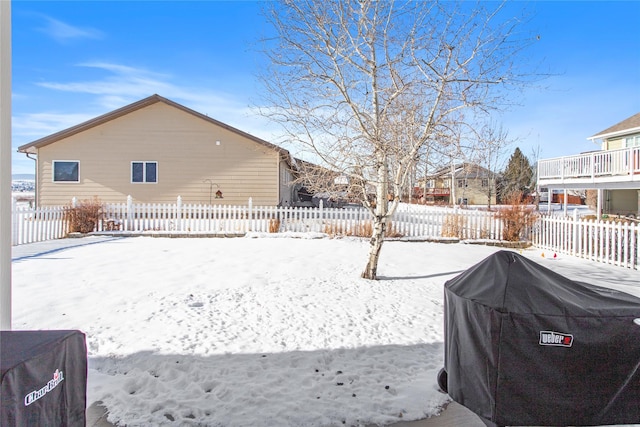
(0, 1), (12, 331)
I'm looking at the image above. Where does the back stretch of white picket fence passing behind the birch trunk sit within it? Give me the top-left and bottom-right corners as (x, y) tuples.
(97, 198), (503, 240)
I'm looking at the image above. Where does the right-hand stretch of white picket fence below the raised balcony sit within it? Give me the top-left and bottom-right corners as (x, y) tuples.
(532, 212), (640, 270)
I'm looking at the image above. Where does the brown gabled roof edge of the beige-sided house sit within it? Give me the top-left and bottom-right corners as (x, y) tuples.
(18, 94), (292, 165)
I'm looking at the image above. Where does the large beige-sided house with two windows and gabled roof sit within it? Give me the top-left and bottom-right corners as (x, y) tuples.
(18, 95), (293, 205)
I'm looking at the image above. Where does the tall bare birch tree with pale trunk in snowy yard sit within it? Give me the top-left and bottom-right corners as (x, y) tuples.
(261, 0), (534, 279)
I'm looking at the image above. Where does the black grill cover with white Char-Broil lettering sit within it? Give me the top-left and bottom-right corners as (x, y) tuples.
(0, 331), (87, 427)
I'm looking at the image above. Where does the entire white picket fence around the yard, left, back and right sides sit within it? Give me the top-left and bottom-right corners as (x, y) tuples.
(11, 198), (640, 270)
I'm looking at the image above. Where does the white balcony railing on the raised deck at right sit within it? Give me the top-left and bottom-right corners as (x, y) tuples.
(538, 147), (640, 185)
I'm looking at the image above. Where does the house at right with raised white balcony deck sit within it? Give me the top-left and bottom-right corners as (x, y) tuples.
(538, 113), (640, 217)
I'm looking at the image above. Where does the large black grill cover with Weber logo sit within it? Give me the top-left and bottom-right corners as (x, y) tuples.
(444, 251), (640, 426)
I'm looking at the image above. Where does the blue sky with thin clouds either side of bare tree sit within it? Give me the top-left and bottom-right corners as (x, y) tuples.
(12, 0), (640, 174)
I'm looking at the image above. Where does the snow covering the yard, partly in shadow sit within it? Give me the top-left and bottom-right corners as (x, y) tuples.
(8, 235), (640, 426)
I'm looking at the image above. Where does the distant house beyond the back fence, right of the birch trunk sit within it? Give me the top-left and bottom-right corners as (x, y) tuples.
(413, 163), (496, 205)
